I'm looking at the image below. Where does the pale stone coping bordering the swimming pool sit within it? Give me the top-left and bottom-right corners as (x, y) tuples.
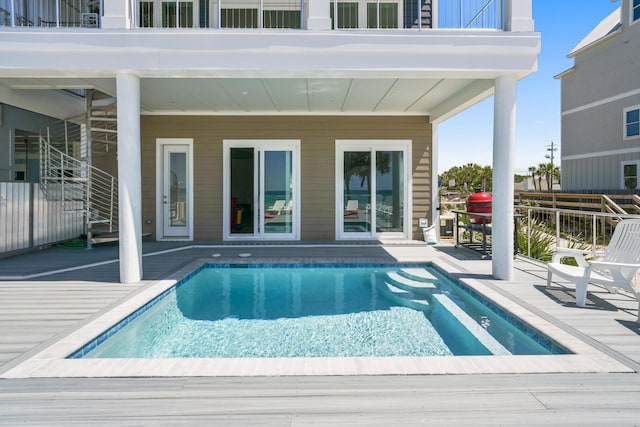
(0, 258), (635, 378)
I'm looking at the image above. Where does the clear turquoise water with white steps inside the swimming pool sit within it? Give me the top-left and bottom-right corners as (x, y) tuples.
(79, 265), (562, 358)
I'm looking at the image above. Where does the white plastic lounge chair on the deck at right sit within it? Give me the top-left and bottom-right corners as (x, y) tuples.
(547, 219), (640, 322)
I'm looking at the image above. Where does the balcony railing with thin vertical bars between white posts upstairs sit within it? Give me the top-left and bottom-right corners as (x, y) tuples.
(0, 0), (504, 30)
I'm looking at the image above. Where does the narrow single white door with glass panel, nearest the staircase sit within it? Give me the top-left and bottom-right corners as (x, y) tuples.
(161, 145), (192, 238)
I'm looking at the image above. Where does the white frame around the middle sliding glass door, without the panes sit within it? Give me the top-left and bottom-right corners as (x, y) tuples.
(222, 139), (302, 241)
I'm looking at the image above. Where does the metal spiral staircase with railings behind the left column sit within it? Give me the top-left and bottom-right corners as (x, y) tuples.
(40, 92), (118, 247)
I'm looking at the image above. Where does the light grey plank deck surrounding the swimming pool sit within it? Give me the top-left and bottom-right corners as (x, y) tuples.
(0, 243), (640, 426)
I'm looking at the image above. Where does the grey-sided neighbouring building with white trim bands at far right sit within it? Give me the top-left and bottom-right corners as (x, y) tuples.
(558, 0), (640, 191)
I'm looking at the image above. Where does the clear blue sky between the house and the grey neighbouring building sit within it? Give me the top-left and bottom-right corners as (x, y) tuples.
(438, 0), (620, 173)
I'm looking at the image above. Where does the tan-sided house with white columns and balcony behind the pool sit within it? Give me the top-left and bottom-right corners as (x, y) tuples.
(0, 0), (540, 281)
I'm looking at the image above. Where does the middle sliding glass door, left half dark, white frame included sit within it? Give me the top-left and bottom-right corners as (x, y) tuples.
(224, 141), (299, 240)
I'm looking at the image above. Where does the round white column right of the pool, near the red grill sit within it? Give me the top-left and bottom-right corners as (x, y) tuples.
(491, 76), (517, 280)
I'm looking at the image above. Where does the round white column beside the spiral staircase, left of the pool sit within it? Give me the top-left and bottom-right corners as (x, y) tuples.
(116, 73), (142, 283)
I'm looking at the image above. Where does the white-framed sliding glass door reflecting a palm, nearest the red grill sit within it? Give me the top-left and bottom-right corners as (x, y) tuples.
(336, 141), (410, 239)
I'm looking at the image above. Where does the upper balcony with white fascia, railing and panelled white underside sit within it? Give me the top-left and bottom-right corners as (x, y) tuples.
(0, 0), (540, 122)
